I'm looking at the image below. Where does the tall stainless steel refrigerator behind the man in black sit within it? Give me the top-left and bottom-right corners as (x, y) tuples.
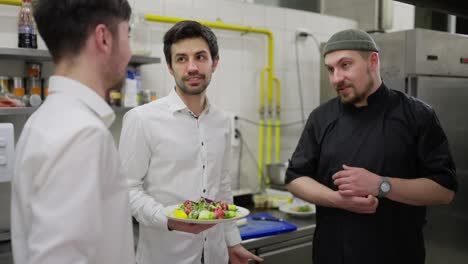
(373, 29), (468, 264)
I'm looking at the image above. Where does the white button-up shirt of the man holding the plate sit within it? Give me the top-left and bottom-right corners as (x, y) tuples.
(119, 90), (241, 264)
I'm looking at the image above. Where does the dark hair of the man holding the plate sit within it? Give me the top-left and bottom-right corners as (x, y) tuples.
(164, 20), (219, 66)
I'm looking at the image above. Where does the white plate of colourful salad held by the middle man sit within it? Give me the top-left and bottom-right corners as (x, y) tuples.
(165, 198), (250, 224)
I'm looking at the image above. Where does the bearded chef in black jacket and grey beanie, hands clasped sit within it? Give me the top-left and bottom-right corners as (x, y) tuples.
(286, 29), (457, 264)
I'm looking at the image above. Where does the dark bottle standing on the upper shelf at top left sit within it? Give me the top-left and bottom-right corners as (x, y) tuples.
(18, 0), (37, 49)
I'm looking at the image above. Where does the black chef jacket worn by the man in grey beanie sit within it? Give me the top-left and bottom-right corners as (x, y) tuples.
(286, 83), (457, 264)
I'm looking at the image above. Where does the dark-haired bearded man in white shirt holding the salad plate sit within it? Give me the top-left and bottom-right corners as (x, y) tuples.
(119, 21), (262, 264)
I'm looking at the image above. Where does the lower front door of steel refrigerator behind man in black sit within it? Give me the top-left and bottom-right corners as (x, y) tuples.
(413, 77), (468, 264)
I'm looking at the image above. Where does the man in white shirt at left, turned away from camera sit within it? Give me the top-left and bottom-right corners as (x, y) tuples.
(11, 0), (135, 264)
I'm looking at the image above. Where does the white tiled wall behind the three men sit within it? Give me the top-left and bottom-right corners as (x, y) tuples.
(0, 0), (357, 194)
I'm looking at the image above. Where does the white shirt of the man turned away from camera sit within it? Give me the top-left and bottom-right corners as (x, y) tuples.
(11, 76), (135, 264)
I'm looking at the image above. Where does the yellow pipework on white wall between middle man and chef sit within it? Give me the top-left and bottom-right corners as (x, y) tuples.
(145, 14), (281, 189)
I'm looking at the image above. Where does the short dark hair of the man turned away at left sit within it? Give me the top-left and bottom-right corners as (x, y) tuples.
(33, 0), (132, 62)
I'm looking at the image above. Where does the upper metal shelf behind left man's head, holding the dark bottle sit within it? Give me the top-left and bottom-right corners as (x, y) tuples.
(0, 48), (161, 66)
